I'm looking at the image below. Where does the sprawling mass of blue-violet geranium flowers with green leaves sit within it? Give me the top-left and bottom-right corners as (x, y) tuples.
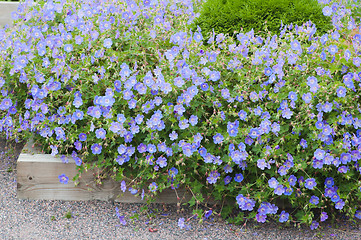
(0, 0), (361, 229)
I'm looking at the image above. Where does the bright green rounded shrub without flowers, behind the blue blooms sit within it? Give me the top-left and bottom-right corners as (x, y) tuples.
(193, 0), (331, 35)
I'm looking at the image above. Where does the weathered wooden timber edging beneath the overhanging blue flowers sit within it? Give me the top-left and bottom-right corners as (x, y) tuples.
(17, 153), (190, 203)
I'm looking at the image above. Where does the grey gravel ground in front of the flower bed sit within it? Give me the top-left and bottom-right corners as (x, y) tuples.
(0, 137), (361, 240)
